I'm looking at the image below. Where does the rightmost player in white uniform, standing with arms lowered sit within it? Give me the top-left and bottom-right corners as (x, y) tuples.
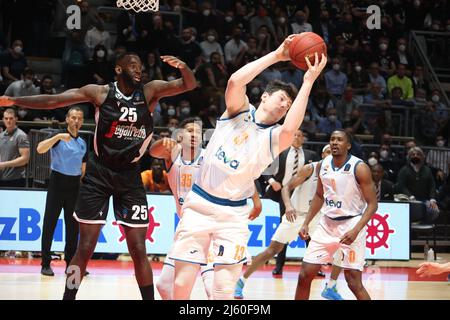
(295, 130), (378, 300)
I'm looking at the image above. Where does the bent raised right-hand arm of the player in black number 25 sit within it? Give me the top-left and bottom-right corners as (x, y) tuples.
(144, 56), (197, 111)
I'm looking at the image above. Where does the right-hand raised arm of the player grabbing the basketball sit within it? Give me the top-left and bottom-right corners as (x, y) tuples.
(274, 53), (327, 152)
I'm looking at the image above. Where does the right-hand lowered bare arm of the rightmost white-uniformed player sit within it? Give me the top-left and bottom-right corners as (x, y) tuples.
(341, 162), (378, 245)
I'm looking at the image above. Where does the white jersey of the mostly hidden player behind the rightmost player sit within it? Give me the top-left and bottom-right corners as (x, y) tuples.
(291, 162), (319, 212)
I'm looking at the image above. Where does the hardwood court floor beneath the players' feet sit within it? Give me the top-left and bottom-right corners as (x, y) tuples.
(0, 254), (450, 300)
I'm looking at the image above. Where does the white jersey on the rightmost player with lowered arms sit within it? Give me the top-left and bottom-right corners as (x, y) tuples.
(320, 154), (366, 219)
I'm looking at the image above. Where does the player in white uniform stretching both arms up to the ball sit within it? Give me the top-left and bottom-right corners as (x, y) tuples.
(170, 36), (326, 299)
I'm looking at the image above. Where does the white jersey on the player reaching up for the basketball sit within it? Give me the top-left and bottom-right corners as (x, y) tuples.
(194, 105), (278, 204)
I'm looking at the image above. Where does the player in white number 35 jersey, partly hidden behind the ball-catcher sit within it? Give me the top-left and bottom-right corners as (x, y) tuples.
(150, 118), (261, 300)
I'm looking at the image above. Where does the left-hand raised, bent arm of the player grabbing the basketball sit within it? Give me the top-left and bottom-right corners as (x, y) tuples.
(223, 36), (293, 118)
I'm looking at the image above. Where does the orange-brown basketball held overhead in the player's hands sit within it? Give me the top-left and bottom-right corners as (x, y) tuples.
(289, 32), (327, 71)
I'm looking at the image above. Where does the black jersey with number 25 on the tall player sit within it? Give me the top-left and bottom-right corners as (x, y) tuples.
(94, 82), (153, 170)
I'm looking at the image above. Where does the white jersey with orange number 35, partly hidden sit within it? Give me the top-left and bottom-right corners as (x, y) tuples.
(167, 148), (205, 216)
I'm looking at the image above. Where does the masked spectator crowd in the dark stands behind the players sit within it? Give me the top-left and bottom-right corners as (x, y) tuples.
(0, 0), (450, 215)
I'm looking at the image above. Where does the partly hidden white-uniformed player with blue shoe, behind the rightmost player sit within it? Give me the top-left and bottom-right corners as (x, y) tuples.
(234, 145), (331, 299)
